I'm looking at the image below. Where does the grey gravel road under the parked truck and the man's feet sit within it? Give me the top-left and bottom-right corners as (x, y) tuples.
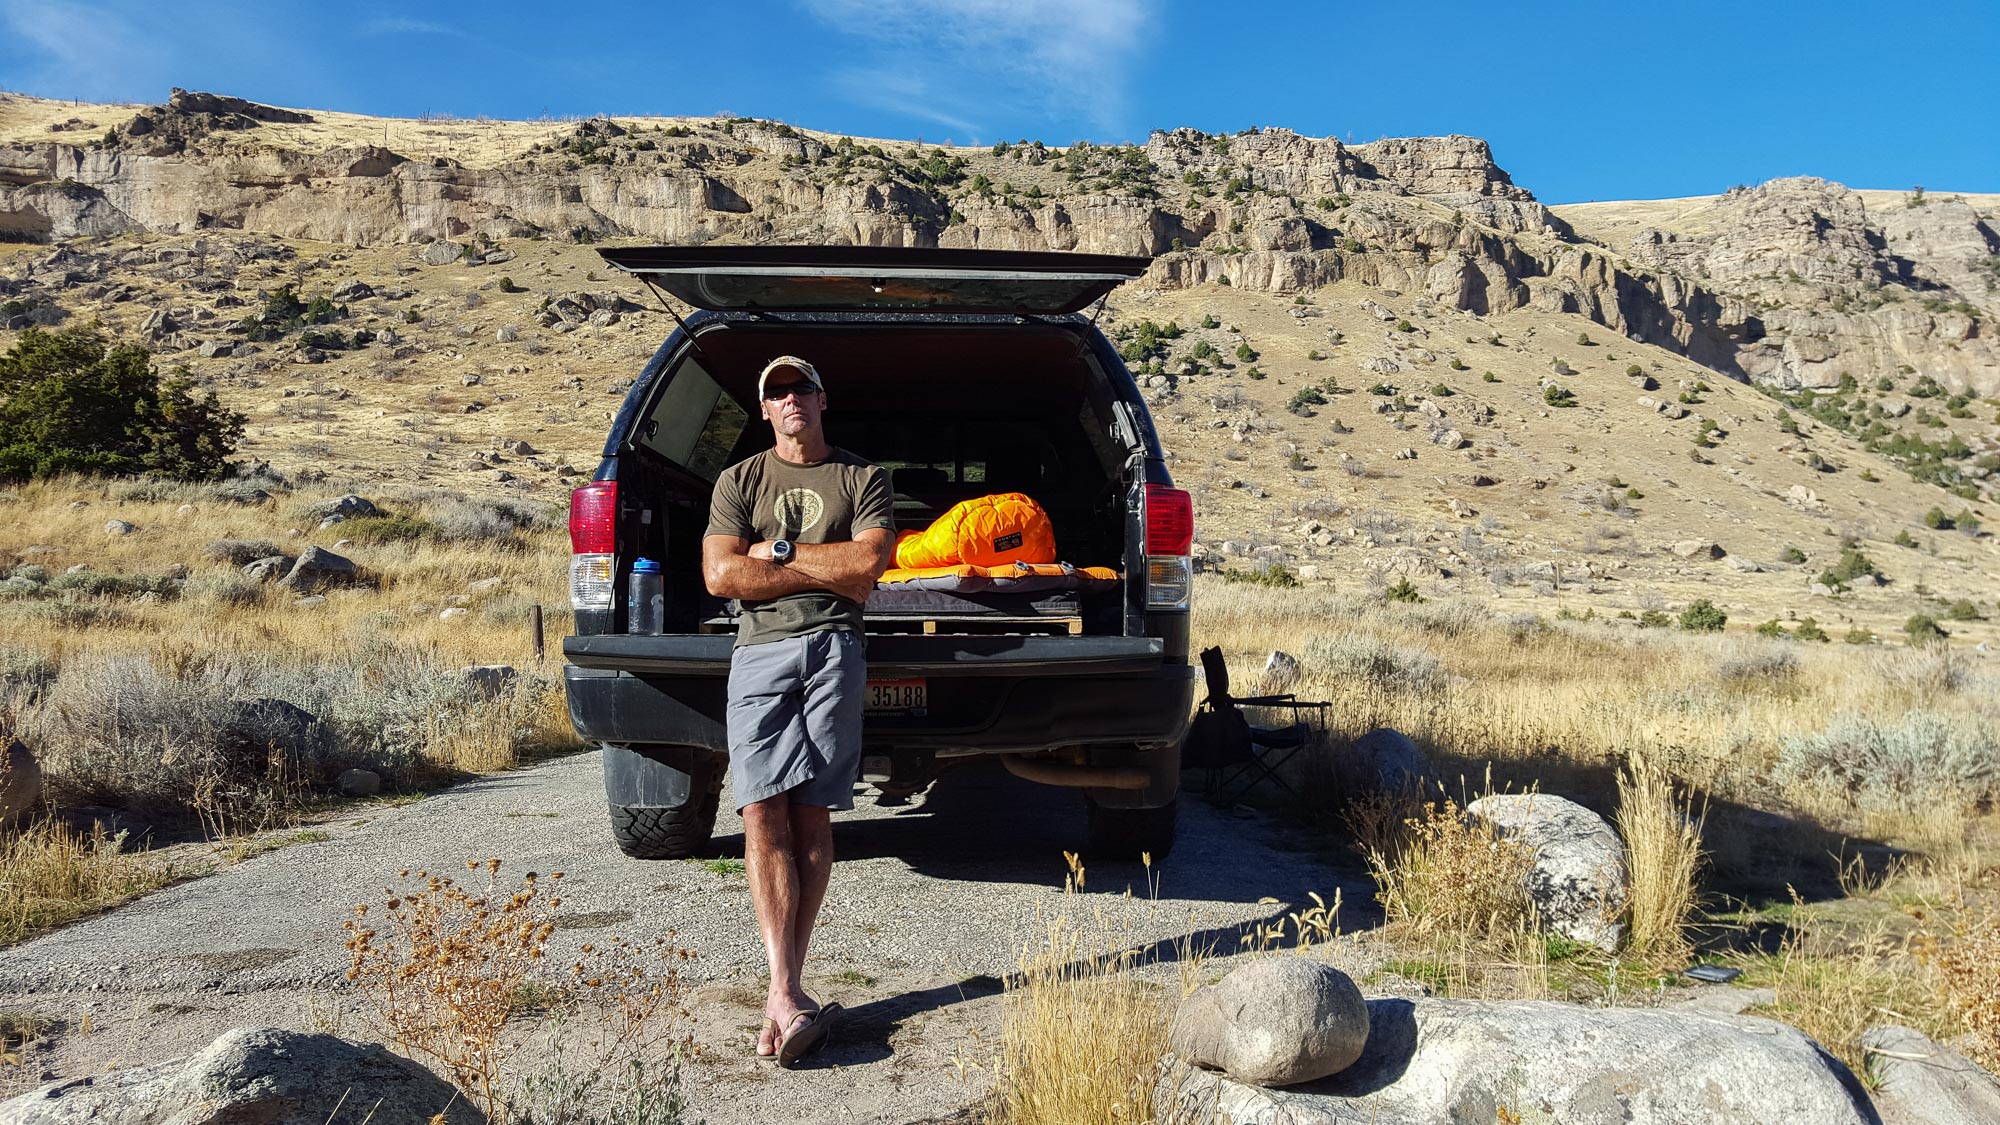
(0, 755), (1368, 1125)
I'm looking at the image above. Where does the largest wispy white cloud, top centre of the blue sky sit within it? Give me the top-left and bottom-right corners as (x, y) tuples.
(802, 0), (1154, 134)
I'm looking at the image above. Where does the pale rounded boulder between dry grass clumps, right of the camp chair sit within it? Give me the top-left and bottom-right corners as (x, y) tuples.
(1466, 793), (1626, 953)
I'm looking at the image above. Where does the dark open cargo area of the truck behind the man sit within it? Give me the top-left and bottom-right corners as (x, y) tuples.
(612, 316), (1146, 637)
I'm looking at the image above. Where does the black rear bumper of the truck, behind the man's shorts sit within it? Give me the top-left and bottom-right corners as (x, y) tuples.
(564, 652), (1194, 755)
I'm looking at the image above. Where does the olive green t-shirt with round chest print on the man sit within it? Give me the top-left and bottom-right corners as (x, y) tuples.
(708, 448), (896, 645)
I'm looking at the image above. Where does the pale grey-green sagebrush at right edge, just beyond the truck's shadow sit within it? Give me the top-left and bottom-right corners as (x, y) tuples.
(1778, 711), (2000, 811)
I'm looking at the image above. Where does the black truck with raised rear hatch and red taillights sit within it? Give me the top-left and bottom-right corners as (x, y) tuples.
(562, 246), (1194, 859)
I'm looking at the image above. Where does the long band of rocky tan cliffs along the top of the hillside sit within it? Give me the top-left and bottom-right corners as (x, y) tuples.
(0, 90), (2000, 394)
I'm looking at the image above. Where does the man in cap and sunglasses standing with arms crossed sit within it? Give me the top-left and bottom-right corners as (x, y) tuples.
(702, 356), (896, 1067)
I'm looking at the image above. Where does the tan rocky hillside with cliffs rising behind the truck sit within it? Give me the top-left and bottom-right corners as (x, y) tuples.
(0, 94), (2000, 643)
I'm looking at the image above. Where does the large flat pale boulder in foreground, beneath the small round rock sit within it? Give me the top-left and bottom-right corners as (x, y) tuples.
(1154, 999), (1876, 1125)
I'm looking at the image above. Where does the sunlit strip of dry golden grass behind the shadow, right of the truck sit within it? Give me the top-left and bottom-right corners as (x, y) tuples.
(1194, 577), (2000, 831)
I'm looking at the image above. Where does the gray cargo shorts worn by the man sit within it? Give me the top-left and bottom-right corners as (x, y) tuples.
(726, 631), (868, 813)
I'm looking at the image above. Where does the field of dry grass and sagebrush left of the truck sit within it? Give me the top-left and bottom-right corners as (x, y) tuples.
(0, 476), (578, 943)
